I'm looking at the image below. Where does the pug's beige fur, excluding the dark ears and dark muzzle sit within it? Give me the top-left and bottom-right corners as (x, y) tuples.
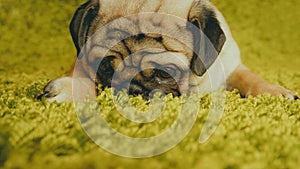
(41, 0), (296, 102)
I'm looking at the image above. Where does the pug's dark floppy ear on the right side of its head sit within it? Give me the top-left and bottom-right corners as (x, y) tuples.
(188, 1), (226, 76)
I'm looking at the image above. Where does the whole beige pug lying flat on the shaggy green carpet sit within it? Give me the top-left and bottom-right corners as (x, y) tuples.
(38, 0), (298, 102)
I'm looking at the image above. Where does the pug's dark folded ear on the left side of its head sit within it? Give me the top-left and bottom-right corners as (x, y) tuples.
(70, 0), (100, 56)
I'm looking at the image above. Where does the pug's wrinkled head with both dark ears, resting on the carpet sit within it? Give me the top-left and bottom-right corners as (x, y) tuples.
(70, 0), (226, 97)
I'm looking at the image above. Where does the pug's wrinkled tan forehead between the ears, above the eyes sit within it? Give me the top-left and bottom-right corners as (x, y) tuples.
(85, 13), (193, 60)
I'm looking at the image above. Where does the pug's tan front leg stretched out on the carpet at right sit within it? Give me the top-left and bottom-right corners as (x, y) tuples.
(227, 64), (298, 100)
